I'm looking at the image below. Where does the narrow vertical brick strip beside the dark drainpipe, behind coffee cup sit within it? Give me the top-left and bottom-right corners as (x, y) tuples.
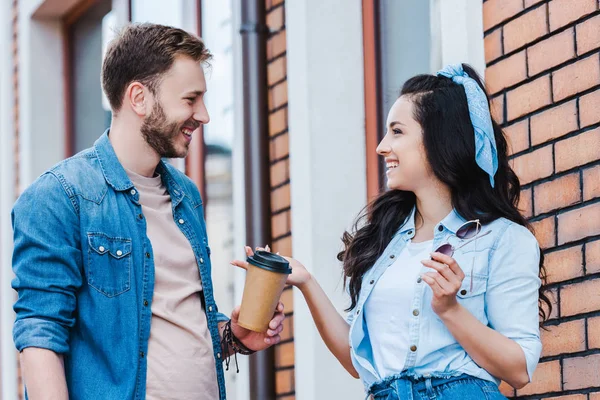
(265, 0), (295, 400)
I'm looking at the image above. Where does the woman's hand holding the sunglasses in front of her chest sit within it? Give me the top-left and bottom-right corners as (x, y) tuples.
(421, 253), (465, 317)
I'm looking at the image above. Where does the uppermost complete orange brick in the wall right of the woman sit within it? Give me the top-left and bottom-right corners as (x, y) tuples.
(504, 4), (548, 53)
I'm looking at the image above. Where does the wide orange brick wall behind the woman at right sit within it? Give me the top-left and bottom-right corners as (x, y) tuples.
(483, 0), (600, 400)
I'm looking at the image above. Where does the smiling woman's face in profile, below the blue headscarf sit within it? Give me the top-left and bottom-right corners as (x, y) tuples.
(377, 96), (435, 192)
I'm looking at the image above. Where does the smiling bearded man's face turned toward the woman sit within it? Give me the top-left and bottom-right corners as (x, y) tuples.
(141, 57), (210, 158)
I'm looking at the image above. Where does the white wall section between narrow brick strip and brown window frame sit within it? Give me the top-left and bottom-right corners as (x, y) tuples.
(285, 0), (366, 400)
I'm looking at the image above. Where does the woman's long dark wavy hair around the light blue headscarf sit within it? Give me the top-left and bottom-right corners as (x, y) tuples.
(338, 64), (552, 321)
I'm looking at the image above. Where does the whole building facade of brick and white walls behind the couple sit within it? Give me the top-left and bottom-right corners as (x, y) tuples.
(0, 0), (600, 400)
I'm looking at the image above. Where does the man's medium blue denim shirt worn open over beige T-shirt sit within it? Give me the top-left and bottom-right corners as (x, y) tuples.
(12, 131), (228, 400)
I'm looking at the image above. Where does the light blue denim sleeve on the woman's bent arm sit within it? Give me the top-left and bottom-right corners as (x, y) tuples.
(486, 223), (542, 381)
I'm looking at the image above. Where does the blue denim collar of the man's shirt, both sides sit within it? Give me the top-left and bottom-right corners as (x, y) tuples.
(94, 129), (185, 205)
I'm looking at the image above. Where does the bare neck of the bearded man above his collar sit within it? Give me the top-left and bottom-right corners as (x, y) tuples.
(108, 118), (160, 177)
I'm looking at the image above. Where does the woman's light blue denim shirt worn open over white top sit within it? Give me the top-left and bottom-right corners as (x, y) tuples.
(347, 209), (542, 390)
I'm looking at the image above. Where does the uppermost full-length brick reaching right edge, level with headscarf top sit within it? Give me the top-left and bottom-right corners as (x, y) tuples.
(552, 54), (600, 101)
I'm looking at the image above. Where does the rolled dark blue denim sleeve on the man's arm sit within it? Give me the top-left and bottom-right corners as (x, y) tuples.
(12, 173), (82, 353)
